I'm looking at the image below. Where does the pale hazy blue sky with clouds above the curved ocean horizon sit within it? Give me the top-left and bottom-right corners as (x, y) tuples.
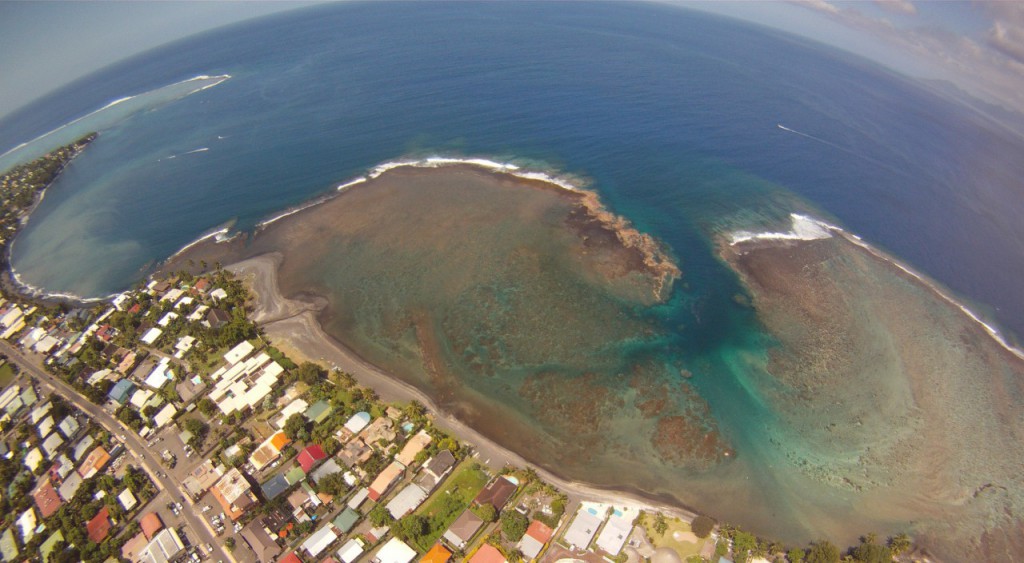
(0, 0), (1024, 118)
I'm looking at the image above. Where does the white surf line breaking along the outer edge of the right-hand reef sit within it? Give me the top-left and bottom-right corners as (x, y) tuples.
(729, 211), (1024, 360)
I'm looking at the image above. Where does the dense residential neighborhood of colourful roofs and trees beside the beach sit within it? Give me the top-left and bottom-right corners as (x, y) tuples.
(0, 269), (737, 563)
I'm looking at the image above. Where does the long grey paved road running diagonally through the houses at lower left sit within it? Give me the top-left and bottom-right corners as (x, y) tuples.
(0, 341), (237, 563)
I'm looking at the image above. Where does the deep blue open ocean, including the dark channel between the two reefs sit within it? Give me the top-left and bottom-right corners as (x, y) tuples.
(6, 2), (1024, 548)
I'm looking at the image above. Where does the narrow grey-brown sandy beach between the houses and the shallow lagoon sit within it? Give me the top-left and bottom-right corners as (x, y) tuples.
(225, 254), (697, 520)
